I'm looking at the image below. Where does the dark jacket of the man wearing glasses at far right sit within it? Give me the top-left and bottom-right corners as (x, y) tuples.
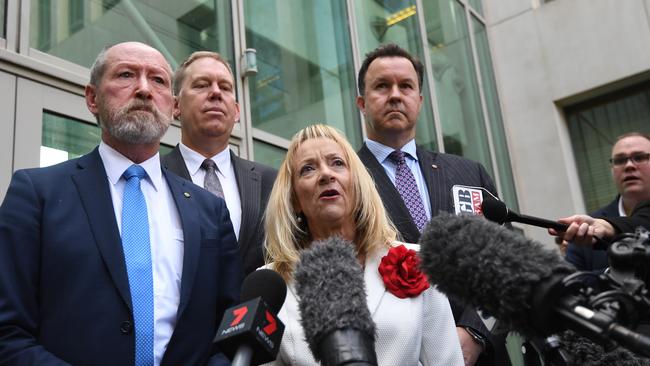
(565, 196), (620, 273)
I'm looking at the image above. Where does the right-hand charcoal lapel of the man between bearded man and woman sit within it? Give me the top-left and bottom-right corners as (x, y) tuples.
(230, 151), (262, 252)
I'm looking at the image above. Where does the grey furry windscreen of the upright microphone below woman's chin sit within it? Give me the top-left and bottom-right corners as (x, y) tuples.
(294, 237), (375, 361)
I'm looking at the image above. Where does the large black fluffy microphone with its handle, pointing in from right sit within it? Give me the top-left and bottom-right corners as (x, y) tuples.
(420, 215), (650, 355)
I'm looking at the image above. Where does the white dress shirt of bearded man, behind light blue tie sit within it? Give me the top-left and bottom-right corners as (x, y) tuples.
(99, 141), (184, 366)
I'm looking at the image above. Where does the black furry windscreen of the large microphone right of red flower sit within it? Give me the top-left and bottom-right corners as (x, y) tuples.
(420, 215), (575, 336)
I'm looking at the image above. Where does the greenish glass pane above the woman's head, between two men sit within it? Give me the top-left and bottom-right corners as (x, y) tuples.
(244, 0), (361, 145)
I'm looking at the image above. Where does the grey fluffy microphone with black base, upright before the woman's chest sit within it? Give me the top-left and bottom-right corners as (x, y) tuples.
(295, 237), (377, 366)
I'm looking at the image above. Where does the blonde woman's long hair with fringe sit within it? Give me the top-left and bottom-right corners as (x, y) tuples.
(264, 124), (397, 281)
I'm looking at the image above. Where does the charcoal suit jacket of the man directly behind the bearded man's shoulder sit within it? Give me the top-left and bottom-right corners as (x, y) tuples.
(161, 145), (278, 274)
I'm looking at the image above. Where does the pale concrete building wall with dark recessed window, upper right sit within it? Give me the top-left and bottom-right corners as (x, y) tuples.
(483, 0), (650, 242)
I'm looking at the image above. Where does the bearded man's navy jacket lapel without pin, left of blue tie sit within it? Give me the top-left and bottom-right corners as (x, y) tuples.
(72, 148), (131, 309)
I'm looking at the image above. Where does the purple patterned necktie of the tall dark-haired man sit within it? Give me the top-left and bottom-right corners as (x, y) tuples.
(388, 150), (428, 231)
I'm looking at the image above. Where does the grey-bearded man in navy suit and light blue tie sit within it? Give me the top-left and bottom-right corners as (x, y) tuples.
(0, 42), (241, 365)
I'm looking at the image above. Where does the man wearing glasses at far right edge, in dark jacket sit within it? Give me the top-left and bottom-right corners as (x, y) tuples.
(566, 132), (650, 271)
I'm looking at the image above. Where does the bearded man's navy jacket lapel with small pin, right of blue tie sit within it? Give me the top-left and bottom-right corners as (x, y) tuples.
(163, 169), (201, 319)
